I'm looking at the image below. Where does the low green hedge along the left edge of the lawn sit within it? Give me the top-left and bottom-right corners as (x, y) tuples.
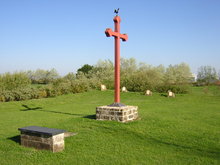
(0, 79), (97, 102)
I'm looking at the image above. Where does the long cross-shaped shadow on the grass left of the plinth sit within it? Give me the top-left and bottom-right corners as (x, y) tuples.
(20, 104), (93, 119)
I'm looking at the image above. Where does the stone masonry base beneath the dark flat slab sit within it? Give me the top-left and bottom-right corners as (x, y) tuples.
(21, 132), (64, 152)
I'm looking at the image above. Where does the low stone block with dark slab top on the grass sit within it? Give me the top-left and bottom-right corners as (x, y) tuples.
(18, 126), (67, 152)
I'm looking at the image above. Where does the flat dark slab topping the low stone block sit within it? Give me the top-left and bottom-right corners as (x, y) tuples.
(18, 126), (67, 136)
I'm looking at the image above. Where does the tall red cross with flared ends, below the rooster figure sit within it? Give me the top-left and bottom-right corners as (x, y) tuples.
(105, 15), (128, 106)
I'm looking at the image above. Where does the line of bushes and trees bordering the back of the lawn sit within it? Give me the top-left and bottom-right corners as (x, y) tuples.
(0, 58), (219, 102)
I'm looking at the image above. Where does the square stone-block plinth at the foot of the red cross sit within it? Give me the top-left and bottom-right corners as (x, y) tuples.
(96, 106), (138, 123)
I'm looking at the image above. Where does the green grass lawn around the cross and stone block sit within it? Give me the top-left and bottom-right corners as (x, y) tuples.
(0, 87), (220, 165)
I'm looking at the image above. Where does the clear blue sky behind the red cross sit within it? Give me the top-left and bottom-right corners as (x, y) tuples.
(0, 0), (220, 75)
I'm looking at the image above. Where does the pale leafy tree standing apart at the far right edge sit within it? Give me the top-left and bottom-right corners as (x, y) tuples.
(197, 66), (218, 85)
